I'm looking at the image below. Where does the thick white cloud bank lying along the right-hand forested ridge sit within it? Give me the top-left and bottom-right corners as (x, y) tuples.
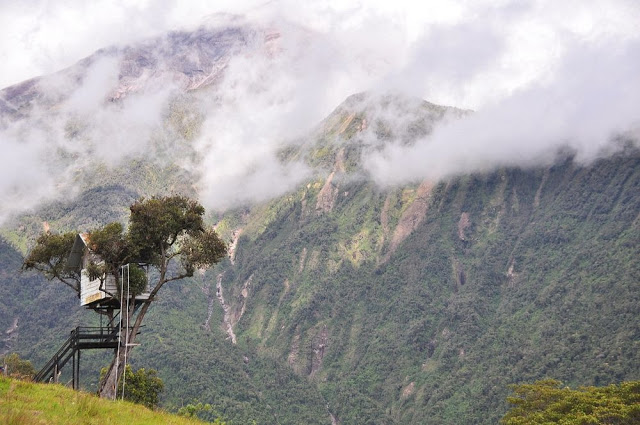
(365, 41), (640, 185)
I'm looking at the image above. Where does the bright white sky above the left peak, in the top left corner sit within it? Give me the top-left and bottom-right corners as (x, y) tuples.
(0, 0), (259, 87)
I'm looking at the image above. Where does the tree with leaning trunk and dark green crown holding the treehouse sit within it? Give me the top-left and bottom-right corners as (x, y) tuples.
(23, 196), (227, 398)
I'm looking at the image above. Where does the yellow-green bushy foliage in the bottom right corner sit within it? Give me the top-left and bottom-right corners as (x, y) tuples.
(501, 379), (640, 425)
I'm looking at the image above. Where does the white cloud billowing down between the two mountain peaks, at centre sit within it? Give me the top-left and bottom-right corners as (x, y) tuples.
(190, 15), (408, 209)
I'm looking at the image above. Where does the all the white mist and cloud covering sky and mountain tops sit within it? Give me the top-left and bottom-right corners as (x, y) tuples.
(0, 0), (640, 222)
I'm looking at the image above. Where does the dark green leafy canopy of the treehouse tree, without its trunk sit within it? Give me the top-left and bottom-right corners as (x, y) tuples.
(23, 196), (227, 295)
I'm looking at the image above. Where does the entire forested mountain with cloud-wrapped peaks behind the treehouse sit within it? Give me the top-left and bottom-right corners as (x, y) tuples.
(0, 22), (640, 425)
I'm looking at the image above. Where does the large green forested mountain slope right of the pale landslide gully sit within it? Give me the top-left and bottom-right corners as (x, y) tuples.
(216, 147), (640, 424)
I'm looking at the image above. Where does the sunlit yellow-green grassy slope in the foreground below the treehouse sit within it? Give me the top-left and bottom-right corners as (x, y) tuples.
(0, 377), (202, 425)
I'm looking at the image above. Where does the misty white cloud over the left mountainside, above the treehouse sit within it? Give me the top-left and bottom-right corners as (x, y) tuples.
(0, 54), (177, 223)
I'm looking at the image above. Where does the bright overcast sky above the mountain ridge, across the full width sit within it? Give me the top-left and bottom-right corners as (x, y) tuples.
(0, 0), (640, 108)
